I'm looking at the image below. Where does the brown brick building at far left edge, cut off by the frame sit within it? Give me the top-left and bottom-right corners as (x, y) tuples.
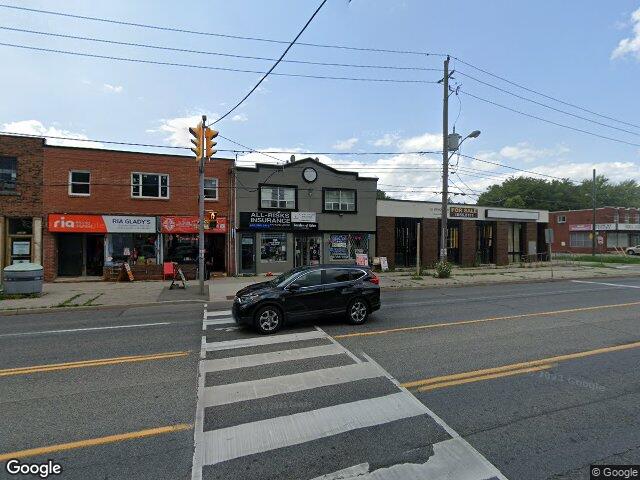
(0, 135), (45, 282)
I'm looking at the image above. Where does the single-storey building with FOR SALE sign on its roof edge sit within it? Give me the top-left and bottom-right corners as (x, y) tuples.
(376, 200), (549, 268)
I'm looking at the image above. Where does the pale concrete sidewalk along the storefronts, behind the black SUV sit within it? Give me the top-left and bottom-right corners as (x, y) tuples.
(0, 263), (640, 312)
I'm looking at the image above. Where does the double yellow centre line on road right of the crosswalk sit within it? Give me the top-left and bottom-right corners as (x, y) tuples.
(401, 342), (640, 391)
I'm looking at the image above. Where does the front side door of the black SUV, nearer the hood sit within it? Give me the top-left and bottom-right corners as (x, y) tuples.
(282, 269), (326, 318)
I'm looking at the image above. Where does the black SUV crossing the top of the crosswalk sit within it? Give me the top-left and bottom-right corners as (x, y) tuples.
(232, 265), (380, 334)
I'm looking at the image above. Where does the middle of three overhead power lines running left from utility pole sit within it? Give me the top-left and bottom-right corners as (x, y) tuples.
(0, 26), (441, 72)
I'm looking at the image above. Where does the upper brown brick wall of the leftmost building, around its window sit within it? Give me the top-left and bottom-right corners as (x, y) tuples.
(0, 135), (44, 217)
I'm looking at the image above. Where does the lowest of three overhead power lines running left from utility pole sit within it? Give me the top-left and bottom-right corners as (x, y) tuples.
(0, 42), (437, 84)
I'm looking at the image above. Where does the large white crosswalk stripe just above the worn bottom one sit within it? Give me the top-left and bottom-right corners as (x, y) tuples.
(203, 392), (424, 465)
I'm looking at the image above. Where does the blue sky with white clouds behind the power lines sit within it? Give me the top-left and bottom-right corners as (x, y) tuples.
(0, 0), (640, 203)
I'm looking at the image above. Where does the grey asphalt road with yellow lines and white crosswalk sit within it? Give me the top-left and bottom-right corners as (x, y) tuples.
(0, 277), (640, 480)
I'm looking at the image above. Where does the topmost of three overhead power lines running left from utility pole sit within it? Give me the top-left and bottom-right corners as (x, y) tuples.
(0, 4), (446, 57)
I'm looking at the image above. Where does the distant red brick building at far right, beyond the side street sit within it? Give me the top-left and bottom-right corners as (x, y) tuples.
(549, 207), (640, 253)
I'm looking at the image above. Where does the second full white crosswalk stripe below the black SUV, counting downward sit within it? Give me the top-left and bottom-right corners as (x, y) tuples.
(200, 343), (344, 374)
